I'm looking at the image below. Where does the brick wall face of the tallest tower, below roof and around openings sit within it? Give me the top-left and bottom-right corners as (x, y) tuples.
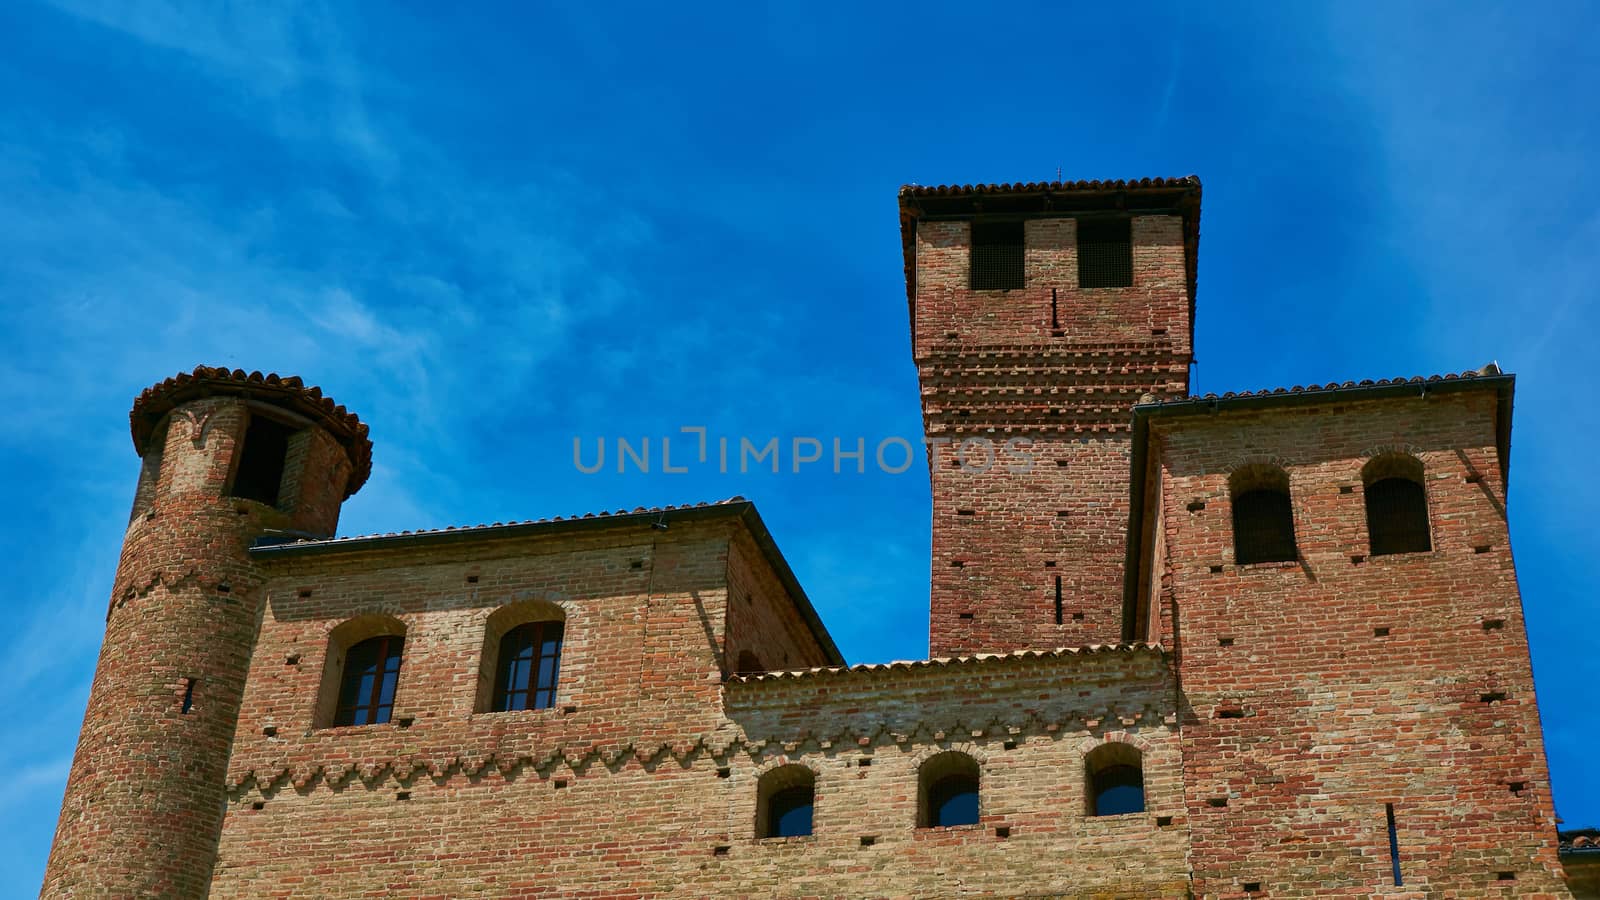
(914, 216), (1192, 657)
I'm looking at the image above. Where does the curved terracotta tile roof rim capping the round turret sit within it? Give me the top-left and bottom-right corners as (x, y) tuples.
(128, 365), (373, 496)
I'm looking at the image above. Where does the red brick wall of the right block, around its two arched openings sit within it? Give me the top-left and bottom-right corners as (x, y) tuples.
(1152, 391), (1562, 897)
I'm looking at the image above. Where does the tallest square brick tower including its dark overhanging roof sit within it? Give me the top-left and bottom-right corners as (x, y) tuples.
(899, 178), (1200, 657)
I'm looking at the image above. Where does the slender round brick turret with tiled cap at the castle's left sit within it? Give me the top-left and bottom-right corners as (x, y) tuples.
(43, 367), (371, 897)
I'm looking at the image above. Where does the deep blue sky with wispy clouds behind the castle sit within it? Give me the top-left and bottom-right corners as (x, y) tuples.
(0, 0), (1600, 895)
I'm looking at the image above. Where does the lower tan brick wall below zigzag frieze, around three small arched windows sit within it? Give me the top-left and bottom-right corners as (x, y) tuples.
(213, 634), (1187, 897)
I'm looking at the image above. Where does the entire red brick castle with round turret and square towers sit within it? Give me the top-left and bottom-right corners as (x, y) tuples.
(43, 178), (1597, 897)
